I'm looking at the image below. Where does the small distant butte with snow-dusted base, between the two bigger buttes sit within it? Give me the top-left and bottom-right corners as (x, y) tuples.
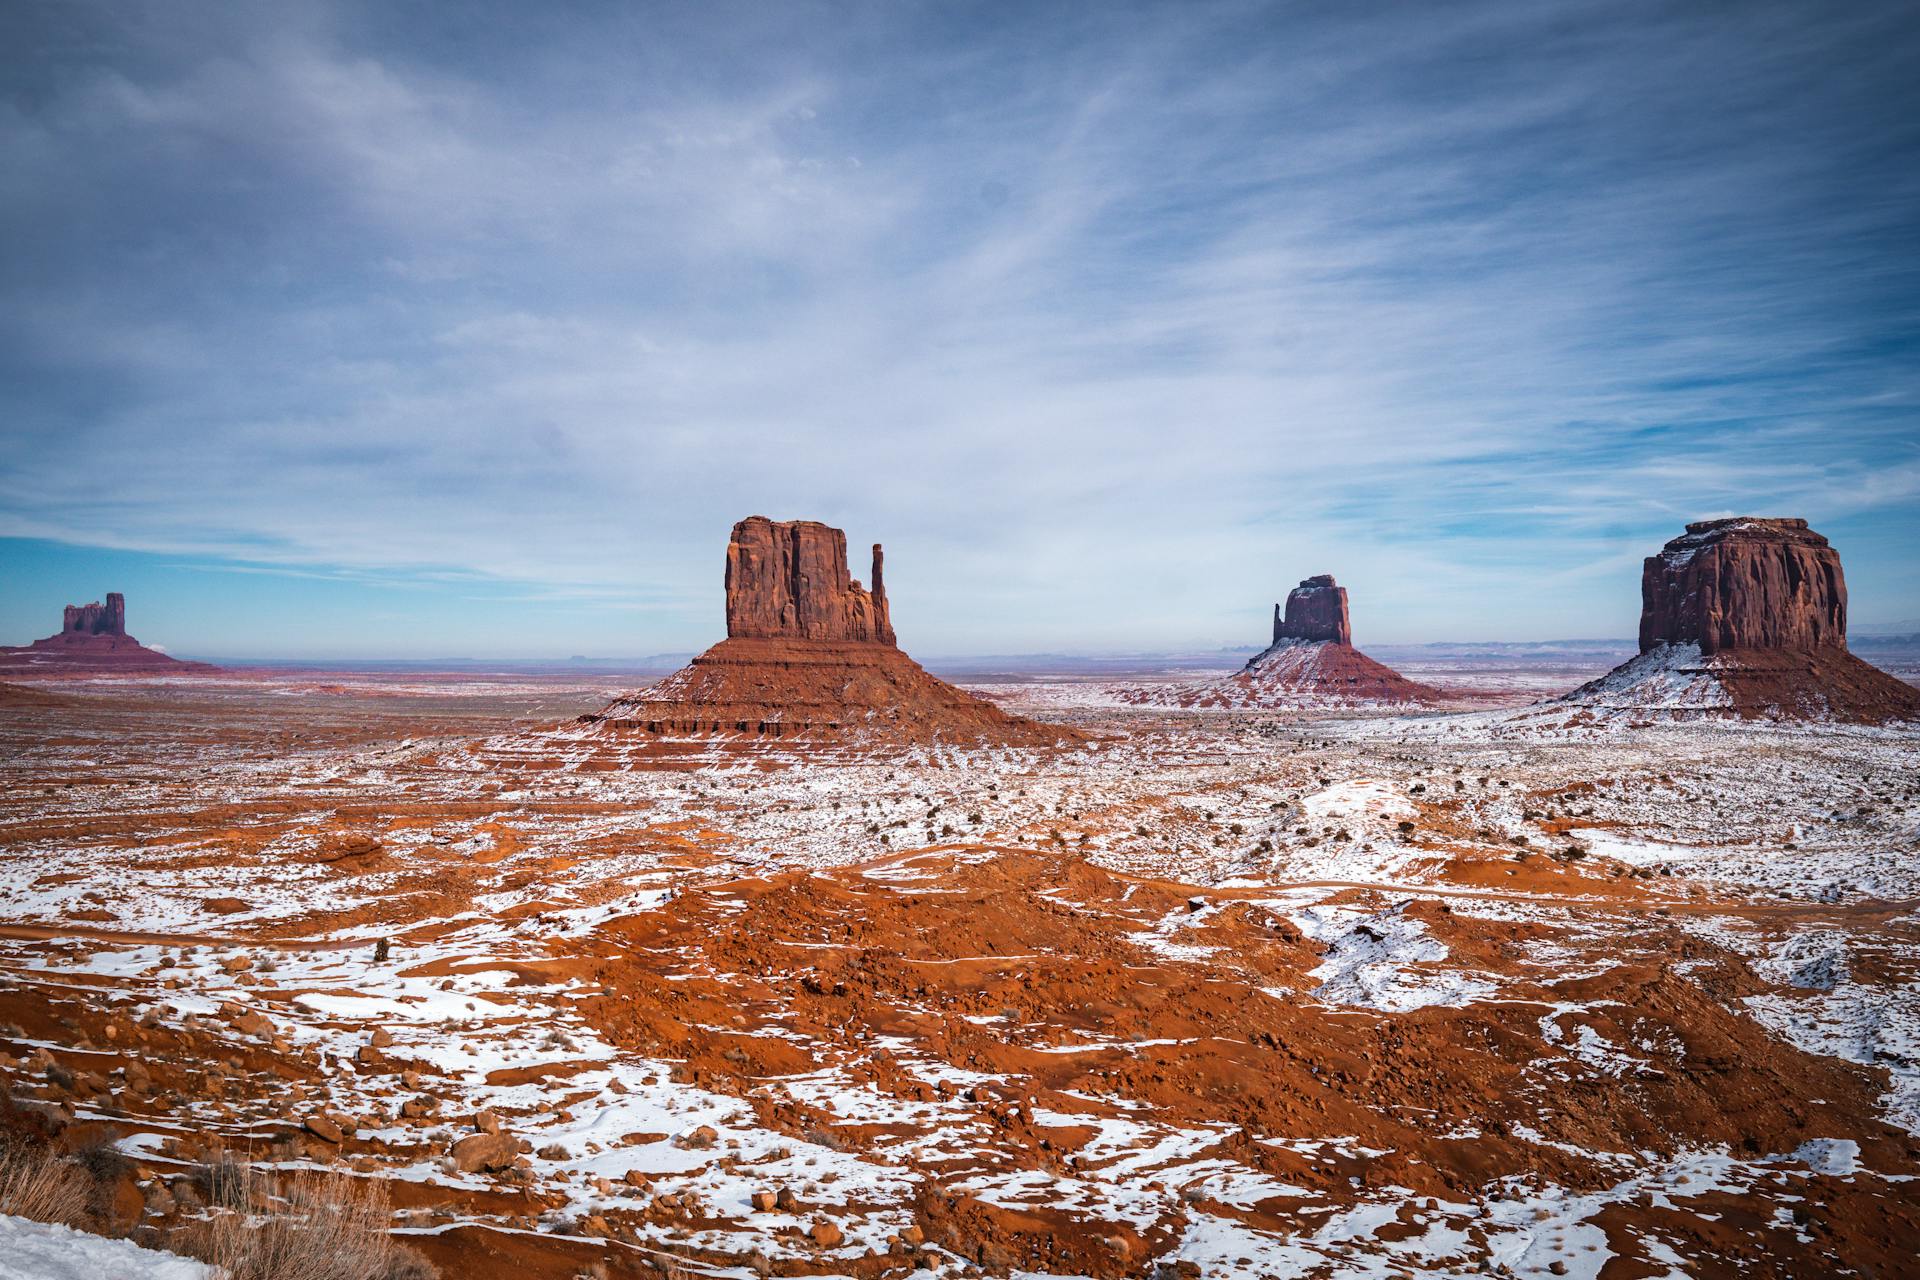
(1123, 574), (1446, 710)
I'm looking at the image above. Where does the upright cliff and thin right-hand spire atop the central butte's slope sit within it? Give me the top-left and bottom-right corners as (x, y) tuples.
(726, 516), (895, 645)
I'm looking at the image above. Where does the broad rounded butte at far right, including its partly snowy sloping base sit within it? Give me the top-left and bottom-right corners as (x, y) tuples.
(1563, 516), (1920, 723)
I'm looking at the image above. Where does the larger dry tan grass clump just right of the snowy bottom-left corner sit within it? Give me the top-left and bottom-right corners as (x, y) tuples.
(180, 1163), (438, 1280)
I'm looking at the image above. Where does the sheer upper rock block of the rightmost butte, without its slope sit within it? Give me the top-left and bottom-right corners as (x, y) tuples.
(1640, 516), (1847, 654)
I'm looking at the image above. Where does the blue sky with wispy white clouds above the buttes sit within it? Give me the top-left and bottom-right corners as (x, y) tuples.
(0, 0), (1920, 658)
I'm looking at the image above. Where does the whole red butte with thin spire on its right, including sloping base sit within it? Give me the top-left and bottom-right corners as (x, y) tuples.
(584, 516), (1079, 747)
